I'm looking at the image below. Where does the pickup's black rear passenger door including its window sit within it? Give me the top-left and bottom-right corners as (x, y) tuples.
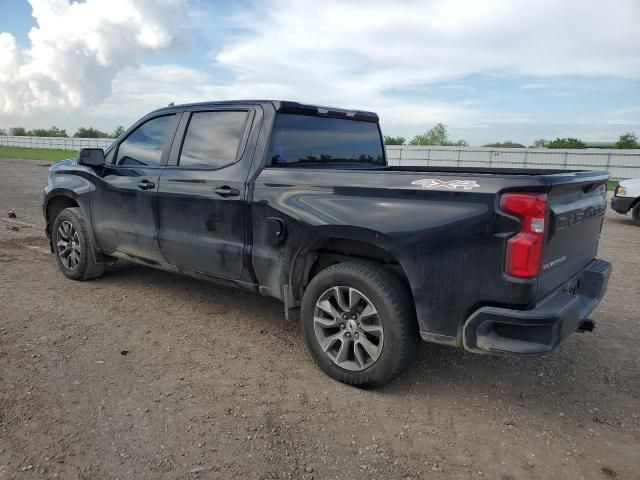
(158, 108), (254, 279)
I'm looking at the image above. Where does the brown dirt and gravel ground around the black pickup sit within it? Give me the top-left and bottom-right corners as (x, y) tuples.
(0, 159), (640, 480)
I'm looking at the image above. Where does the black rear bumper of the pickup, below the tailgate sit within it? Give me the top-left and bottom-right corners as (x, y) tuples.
(463, 260), (611, 355)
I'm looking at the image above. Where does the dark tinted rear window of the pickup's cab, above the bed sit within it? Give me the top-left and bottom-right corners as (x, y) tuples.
(270, 113), (385, 167)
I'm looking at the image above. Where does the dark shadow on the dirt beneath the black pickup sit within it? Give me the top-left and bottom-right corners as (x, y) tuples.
(98, 263), (624, 411)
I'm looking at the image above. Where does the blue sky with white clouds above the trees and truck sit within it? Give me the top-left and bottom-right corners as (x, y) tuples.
(0, 0), (640, 145)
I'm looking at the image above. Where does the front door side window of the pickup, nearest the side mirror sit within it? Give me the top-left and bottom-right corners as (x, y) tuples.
(116, 115), (174, 167)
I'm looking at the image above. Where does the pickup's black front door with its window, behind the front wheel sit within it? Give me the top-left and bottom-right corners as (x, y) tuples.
(91, 114), (178, 263)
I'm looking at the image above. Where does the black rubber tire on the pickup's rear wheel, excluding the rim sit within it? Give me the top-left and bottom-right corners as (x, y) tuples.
(301, 262), (419, 388)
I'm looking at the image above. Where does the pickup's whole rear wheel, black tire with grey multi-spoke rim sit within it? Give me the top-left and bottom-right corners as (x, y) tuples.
(302, 262), (418, 388)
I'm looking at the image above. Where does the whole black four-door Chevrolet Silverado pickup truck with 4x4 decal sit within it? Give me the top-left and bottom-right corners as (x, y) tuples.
(44, 101), (611, 387)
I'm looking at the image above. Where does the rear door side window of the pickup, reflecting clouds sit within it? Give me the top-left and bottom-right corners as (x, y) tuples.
(178, 111), (248, 168)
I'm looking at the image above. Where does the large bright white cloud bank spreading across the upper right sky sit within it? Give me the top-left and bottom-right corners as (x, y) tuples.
(204, 0), (640, 129)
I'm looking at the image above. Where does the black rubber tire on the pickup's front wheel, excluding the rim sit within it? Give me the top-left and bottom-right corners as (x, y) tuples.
(51, 207), (104, 281)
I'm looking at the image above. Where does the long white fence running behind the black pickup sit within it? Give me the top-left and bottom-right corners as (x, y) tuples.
(0, 135), (640, 179)
